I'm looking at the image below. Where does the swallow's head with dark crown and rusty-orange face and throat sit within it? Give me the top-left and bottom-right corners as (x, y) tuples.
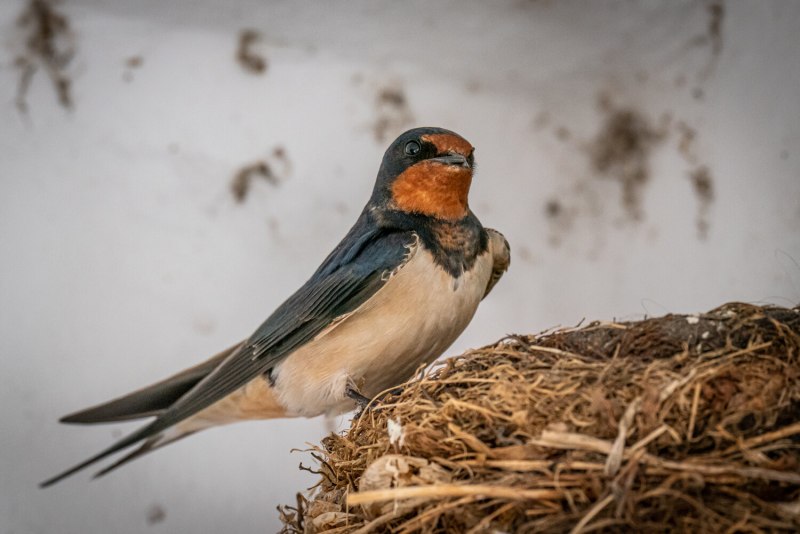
(372, 128), (475, 221)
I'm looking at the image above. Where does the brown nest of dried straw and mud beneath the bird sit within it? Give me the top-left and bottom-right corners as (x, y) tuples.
(280, 303), (800, 533)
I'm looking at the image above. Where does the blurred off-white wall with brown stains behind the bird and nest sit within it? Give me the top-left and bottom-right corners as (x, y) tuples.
(0, 0), (800, 533)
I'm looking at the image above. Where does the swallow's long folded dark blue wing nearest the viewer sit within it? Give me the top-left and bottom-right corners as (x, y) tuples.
(42, 216), (415, 486)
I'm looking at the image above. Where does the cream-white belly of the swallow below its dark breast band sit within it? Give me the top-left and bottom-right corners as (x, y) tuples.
(273, 241), (493, 417)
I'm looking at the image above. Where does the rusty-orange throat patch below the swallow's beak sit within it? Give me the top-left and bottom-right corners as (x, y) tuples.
(392, 160), (472, 221)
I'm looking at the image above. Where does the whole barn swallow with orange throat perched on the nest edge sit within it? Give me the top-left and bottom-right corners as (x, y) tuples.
(41, 128), (510, 487)
